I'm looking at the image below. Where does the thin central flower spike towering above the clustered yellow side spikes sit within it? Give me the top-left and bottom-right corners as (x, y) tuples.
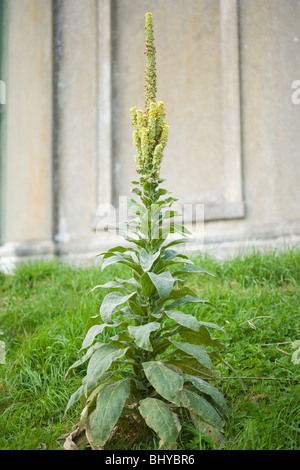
(145, 12), (157, 114)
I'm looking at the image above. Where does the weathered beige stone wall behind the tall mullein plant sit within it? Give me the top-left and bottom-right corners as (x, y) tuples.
(0, 0), (300, 264)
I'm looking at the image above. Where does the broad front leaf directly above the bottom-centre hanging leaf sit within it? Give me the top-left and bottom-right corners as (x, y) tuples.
(142, 361), (184, 405)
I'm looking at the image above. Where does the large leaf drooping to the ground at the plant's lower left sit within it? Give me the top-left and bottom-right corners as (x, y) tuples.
(89, 379), (130, 446)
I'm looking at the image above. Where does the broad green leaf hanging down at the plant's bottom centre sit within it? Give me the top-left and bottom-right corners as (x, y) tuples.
(139, 398), (181, 449)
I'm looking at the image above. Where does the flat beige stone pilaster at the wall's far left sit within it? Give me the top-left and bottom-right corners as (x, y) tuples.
(1, 0), (52, 248)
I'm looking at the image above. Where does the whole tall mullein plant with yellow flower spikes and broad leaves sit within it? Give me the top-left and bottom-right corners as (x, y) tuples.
(65, 13), (232, 449)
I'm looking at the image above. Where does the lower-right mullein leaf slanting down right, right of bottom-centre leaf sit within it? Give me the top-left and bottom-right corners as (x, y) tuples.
(181, 390), (224, 429)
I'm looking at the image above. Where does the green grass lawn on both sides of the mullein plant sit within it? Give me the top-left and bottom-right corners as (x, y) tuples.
(0, 249), (300, 450)
